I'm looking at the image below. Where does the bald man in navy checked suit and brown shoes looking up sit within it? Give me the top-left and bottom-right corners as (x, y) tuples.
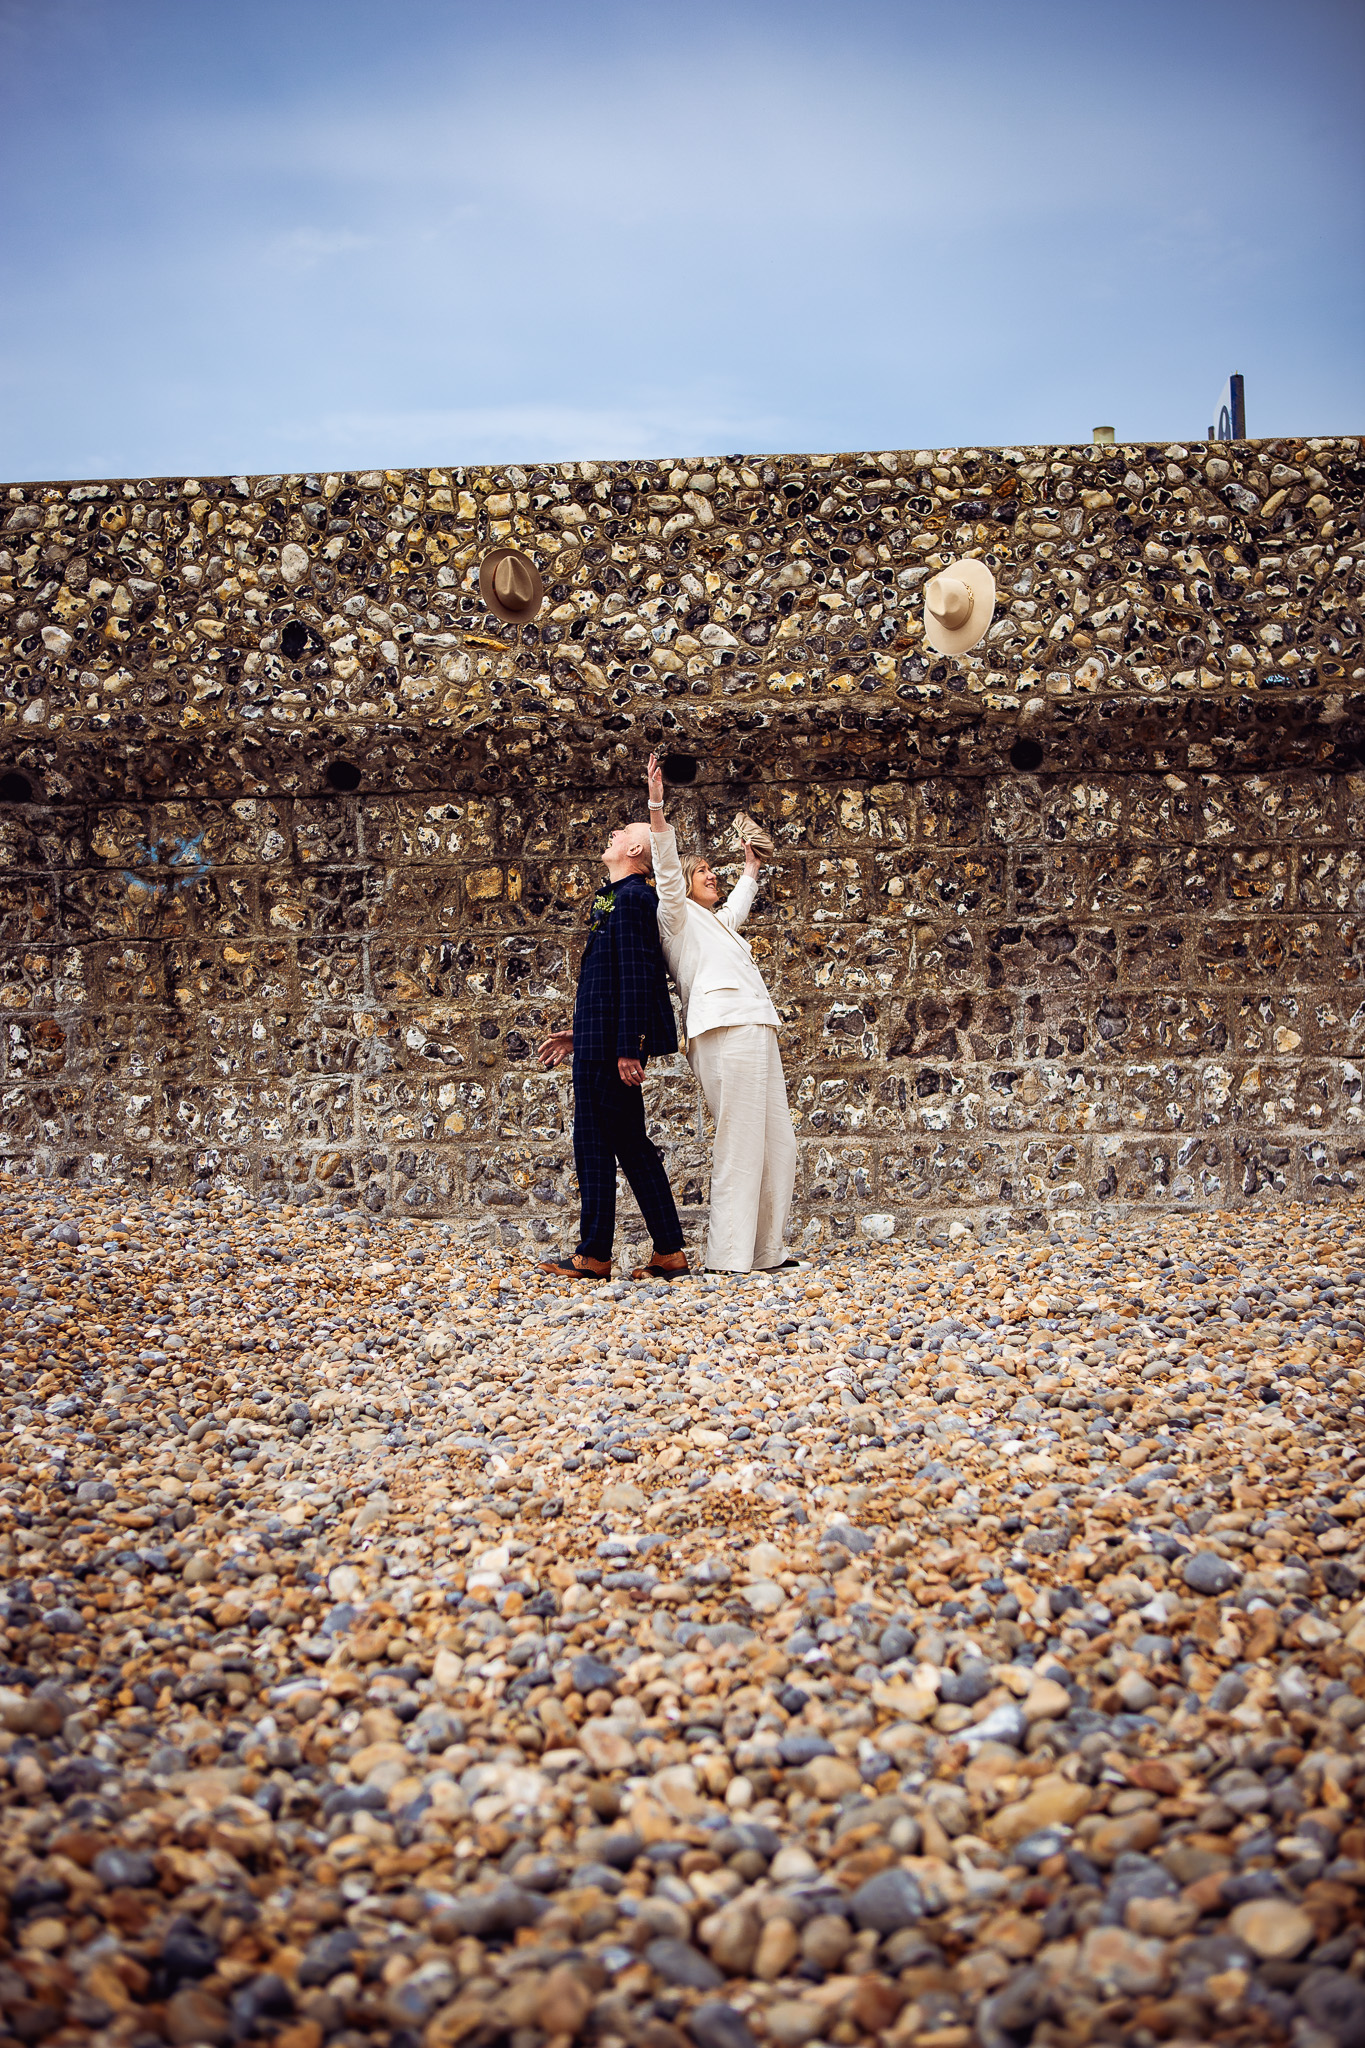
(536, 825), (688, 1280)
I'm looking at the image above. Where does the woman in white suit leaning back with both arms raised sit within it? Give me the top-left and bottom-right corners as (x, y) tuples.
(649, 754), (798, 1274)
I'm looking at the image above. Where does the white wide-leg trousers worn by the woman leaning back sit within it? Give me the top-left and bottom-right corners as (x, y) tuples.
(688, 1024), (796, 1274)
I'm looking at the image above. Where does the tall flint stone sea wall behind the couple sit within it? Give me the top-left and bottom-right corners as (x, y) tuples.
(0, 438), (1365, 1245)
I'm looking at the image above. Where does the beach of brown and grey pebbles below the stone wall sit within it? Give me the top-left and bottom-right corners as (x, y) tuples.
(0, 1182), (1365, 2048)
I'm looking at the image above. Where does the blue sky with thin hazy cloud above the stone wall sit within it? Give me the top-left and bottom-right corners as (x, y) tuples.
(0, 0), (1365, 479)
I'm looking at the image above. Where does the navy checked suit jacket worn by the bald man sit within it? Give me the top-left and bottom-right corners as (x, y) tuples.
(573, 874), (677, 1061)
